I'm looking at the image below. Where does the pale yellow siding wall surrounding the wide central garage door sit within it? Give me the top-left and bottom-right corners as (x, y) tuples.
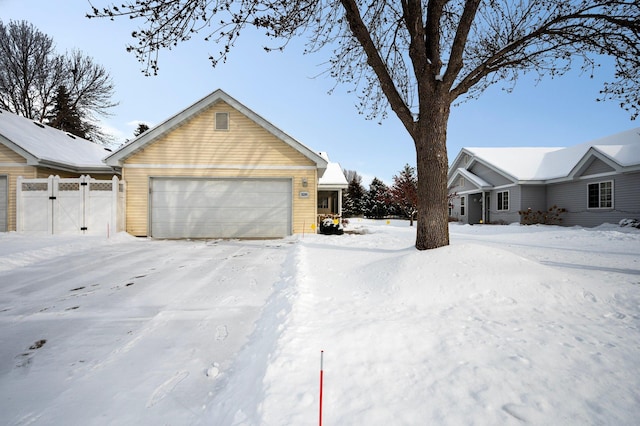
(122, 102), (317, 236)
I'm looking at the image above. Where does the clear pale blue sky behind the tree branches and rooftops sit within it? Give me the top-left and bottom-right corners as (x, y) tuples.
(0, 0), (640, 187)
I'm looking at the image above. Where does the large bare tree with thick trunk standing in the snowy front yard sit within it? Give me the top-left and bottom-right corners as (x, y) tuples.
(89, 0), (640, 250)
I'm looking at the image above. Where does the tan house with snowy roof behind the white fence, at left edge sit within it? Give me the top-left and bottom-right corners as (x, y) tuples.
(0, 109), (114, 232)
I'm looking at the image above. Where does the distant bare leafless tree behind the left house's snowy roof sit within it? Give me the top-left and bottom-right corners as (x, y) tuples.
(0, 21), (117, 143)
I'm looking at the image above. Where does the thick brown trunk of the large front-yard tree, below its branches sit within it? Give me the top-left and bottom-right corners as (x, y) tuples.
(413, 99), (450, 250)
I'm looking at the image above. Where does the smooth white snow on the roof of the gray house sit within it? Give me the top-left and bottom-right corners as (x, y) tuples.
(465, 128), (640, 180)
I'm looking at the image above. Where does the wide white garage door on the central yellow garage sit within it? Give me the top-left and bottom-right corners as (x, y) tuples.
(150, 178), (292, 238)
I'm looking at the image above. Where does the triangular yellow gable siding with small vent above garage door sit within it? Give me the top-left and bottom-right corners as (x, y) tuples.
(127, 102), (313, 166)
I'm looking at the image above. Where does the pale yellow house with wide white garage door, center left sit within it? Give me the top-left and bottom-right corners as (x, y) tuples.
(105, 90), (346, 238)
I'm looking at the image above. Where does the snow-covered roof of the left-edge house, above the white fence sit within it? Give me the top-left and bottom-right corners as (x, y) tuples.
(0, 109), (111, 173)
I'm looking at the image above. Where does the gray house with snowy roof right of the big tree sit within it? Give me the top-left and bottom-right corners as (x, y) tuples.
(448, 128), (640, 227)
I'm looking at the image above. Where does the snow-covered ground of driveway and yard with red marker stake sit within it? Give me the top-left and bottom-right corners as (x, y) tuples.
(0, 220), (640, 426)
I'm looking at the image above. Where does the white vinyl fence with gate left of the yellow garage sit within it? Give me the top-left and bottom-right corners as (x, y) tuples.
(16, 176), (126, 237)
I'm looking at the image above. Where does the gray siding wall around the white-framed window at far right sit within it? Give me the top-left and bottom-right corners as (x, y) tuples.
(547, 172), (640, 227)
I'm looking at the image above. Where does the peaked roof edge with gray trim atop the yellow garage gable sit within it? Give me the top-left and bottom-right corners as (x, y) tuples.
(105, 89), (327, 176)
